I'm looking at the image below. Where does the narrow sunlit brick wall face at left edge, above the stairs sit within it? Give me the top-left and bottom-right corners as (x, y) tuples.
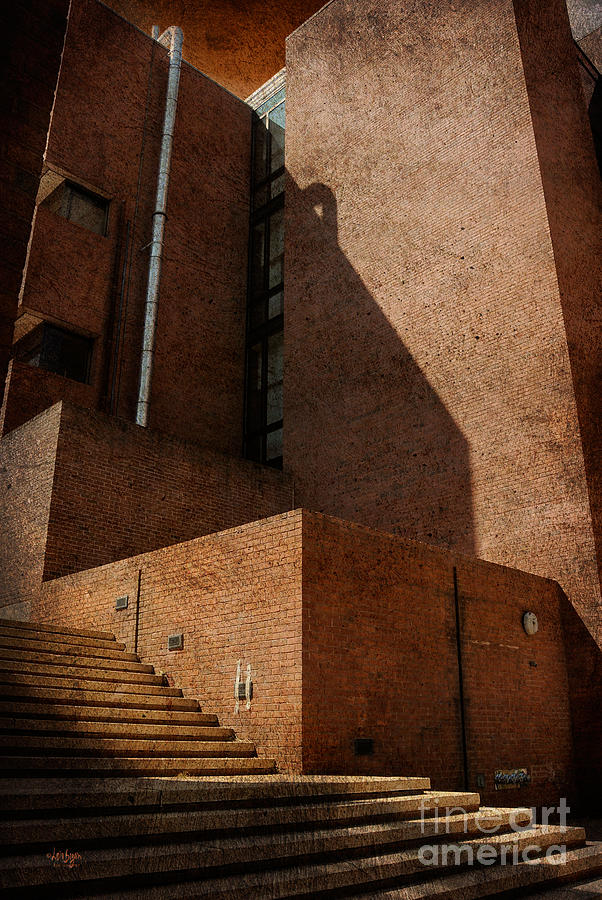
(0, 406), (61, 618)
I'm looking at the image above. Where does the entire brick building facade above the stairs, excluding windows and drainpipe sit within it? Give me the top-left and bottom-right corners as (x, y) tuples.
(0, 0), (602, 804)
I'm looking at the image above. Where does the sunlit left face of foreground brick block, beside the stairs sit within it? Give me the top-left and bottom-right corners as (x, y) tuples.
(32, 511), (301, 771)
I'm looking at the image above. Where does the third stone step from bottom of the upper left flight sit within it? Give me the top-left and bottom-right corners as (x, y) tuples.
(0, 716), (234, 741)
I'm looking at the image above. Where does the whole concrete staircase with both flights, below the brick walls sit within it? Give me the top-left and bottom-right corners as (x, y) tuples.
(0, 622), (602, 900)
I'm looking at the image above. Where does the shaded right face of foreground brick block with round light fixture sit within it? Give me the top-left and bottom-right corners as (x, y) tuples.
(303, 512), (572, 805)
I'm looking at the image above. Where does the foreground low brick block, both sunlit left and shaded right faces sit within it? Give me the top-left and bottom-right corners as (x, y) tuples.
(32, 510), (572, 805)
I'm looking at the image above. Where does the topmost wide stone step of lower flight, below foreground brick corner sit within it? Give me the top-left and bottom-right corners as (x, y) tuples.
(0, 774), (432, 815)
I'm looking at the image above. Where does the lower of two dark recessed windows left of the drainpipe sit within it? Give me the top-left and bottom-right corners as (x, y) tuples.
(16, 322), (94, 384)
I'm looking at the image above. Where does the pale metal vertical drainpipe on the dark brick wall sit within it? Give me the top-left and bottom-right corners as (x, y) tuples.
(136, 25), (184, 428)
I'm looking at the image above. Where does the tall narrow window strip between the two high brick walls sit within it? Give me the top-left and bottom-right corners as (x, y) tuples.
(245, 74), (285, 468)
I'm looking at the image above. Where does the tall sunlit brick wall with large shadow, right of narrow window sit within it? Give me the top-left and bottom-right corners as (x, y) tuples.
(284, 0), (602, 648)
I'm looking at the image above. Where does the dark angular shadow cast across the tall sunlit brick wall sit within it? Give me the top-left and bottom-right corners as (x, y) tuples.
(284, 174), (475, 554)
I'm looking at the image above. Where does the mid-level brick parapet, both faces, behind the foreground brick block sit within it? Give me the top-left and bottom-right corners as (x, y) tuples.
(0, 403), (292, 616)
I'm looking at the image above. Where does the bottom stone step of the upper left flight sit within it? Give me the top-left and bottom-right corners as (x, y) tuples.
(0, 756), (275, 776)
